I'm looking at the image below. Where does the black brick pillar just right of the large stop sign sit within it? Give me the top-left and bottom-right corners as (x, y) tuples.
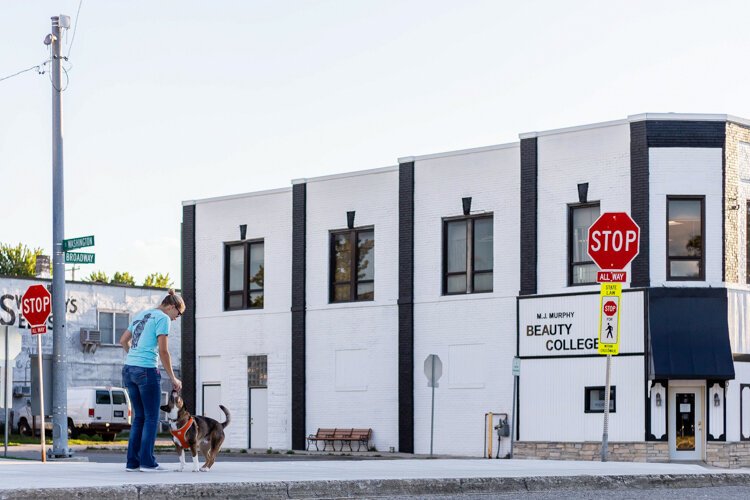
(630, 121), (651, 287)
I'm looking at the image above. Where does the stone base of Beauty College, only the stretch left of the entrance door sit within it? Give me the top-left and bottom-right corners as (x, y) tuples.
(513, 441), (669, 462)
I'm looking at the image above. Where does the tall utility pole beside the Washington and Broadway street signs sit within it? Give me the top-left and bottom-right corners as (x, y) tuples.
(50, 15), (70, 457)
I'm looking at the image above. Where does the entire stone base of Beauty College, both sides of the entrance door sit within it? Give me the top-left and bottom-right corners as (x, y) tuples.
(513, 441), (750, 469)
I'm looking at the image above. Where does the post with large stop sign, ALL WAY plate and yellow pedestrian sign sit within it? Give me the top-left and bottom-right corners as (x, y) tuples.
(588, 212), (641, 462)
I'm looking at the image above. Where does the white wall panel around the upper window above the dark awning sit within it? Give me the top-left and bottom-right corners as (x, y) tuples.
(649, 148), (724, 287)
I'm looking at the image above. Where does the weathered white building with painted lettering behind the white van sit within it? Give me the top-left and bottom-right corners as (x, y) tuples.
(0, 277), (181, 432)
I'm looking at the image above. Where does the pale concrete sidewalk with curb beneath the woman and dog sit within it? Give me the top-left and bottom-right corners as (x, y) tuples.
(0, 457), (750, 500)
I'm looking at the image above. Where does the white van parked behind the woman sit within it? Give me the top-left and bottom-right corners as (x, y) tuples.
(17, 386), (132, 441)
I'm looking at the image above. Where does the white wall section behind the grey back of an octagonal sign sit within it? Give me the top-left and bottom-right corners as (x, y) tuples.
(414, 144), (520, 456)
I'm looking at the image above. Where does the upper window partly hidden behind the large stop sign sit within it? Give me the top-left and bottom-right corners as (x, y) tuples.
(568, 203), (599, 285)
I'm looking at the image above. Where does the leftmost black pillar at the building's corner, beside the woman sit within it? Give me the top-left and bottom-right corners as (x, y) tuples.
(180, 205), (197, 409)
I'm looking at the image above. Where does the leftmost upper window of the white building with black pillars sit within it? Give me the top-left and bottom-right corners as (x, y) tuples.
(224, 240), (264, 311)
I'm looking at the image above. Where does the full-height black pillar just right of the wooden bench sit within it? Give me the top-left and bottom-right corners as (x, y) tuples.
(398, 161), (414, 453)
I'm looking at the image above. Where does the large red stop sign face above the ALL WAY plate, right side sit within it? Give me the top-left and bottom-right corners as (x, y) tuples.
(588, 212), (641, 270)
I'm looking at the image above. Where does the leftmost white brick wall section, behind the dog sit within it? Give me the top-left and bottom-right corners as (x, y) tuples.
(191, 189), (292, 454)
